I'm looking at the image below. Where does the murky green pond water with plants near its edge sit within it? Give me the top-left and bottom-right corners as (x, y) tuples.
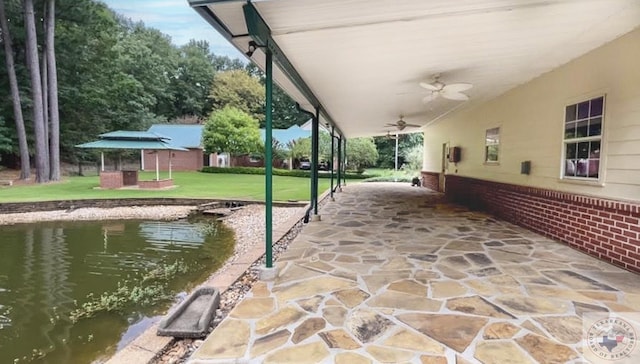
(0, 218), (234, 364)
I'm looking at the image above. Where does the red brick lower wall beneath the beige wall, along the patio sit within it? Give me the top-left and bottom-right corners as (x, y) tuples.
(445, 175), (640, 272)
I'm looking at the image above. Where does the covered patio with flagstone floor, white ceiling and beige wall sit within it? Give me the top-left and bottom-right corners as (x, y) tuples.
(181, 0), (640, 363)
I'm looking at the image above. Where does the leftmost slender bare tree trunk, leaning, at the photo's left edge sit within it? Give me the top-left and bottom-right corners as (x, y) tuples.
(0, 0), (31, 179)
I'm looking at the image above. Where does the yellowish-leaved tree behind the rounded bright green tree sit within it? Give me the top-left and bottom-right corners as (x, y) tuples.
(209, 70), (264, 121)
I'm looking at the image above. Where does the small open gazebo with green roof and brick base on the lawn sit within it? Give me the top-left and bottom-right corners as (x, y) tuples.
(76, 130), (187, 188)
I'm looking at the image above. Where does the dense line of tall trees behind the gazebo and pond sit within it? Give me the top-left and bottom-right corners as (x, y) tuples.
(0, 0), (305, 182)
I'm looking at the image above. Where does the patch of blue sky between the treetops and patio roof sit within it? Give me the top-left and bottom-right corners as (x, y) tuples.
(101, 0), (243, 58)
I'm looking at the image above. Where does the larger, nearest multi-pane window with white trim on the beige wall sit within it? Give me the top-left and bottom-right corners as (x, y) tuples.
(562, 96), (604, 180)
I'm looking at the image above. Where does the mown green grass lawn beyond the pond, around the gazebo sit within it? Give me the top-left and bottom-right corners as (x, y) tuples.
(0, 172), (340, 203)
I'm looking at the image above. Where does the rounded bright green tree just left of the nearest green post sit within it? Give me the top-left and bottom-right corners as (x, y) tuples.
(202, 106), (263, 164)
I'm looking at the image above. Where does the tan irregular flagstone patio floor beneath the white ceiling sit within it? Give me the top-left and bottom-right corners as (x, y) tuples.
(190, 183), (640, 364)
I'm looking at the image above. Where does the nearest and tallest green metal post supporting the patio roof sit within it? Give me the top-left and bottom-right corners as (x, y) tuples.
(264, 48), (273, 268)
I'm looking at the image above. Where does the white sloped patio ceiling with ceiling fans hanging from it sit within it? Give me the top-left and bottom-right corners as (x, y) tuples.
(190, 0), (640, 137)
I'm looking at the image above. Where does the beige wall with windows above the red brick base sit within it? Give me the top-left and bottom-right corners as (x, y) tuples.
(424, 29), (640, 201)
